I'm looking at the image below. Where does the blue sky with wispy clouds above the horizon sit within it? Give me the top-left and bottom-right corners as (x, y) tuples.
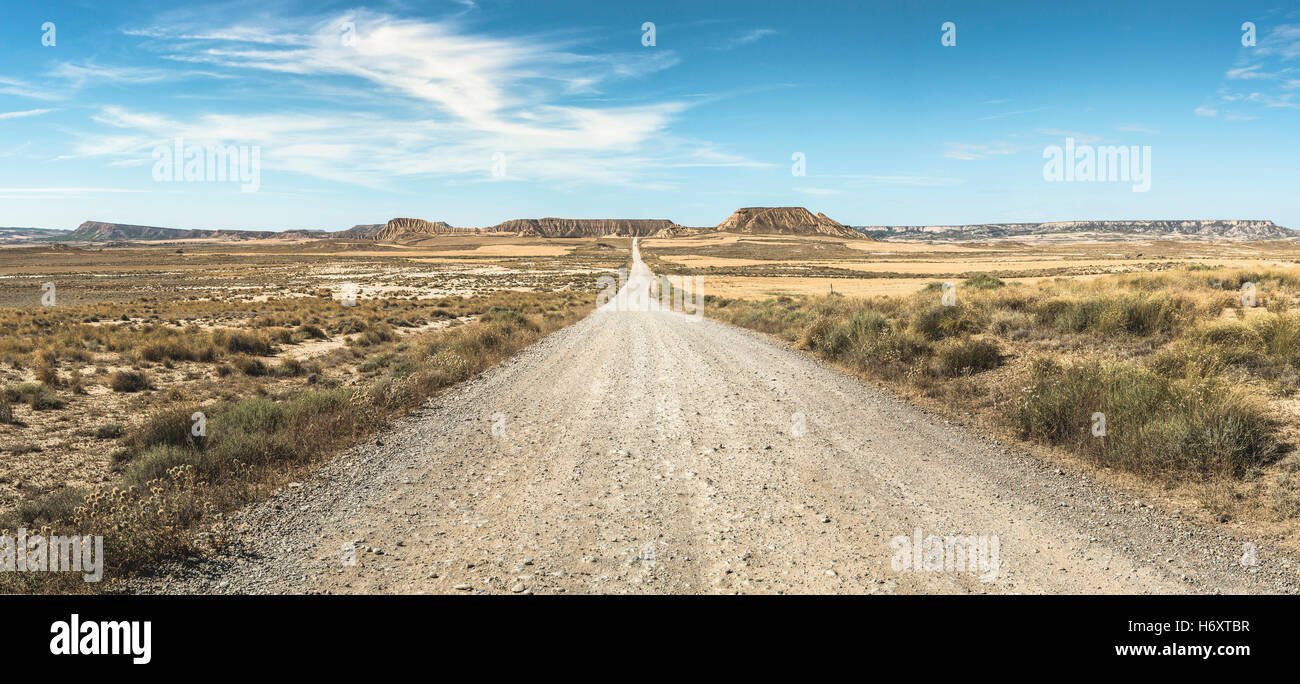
(0, 0), (1300, 230)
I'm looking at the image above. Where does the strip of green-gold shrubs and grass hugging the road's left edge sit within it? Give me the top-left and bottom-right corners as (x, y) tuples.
(0, 295), (590, 592)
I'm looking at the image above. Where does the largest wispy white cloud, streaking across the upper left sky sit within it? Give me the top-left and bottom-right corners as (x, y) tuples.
(61, 12), (759, 187)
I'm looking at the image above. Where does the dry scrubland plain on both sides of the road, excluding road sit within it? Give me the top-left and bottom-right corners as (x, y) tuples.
(0, 233), (1300, 590)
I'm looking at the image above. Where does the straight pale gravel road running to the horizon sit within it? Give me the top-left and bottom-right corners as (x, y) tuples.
(133, 243), (1297, 593)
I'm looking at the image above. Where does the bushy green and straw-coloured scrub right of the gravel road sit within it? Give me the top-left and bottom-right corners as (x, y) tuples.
(706, 268), (1300, 520)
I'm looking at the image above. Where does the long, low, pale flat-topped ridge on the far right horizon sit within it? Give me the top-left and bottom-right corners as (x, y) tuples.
(857, 220), (1300, 242)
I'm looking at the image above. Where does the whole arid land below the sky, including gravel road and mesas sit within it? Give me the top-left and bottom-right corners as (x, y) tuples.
(0, 208), (1300, 593)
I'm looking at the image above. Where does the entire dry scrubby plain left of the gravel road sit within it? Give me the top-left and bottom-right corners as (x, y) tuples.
(0, 239), (616, 592)
